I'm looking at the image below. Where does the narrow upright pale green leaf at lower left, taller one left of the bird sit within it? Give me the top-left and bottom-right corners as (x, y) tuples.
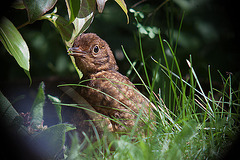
(31, 82), (45, 128)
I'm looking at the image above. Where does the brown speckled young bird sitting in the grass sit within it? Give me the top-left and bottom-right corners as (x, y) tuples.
(68, 33), (153, 132)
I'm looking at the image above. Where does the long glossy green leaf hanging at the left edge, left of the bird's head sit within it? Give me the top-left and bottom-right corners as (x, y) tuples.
(0, 17), (30, 71)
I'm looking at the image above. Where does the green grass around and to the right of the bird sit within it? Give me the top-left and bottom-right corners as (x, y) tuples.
(62, 34), (240, 160)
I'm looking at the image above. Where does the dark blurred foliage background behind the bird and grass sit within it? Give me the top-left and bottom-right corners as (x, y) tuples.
(0, 0), (240, 123)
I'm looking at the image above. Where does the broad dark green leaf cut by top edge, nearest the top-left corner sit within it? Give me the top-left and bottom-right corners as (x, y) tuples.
(23, 0), (57, 23)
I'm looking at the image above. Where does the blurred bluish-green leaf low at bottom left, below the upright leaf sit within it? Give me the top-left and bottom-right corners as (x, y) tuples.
(32, 123), (76, 158)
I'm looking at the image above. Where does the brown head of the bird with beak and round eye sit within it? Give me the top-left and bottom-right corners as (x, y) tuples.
(68, 33), (118, 76)
